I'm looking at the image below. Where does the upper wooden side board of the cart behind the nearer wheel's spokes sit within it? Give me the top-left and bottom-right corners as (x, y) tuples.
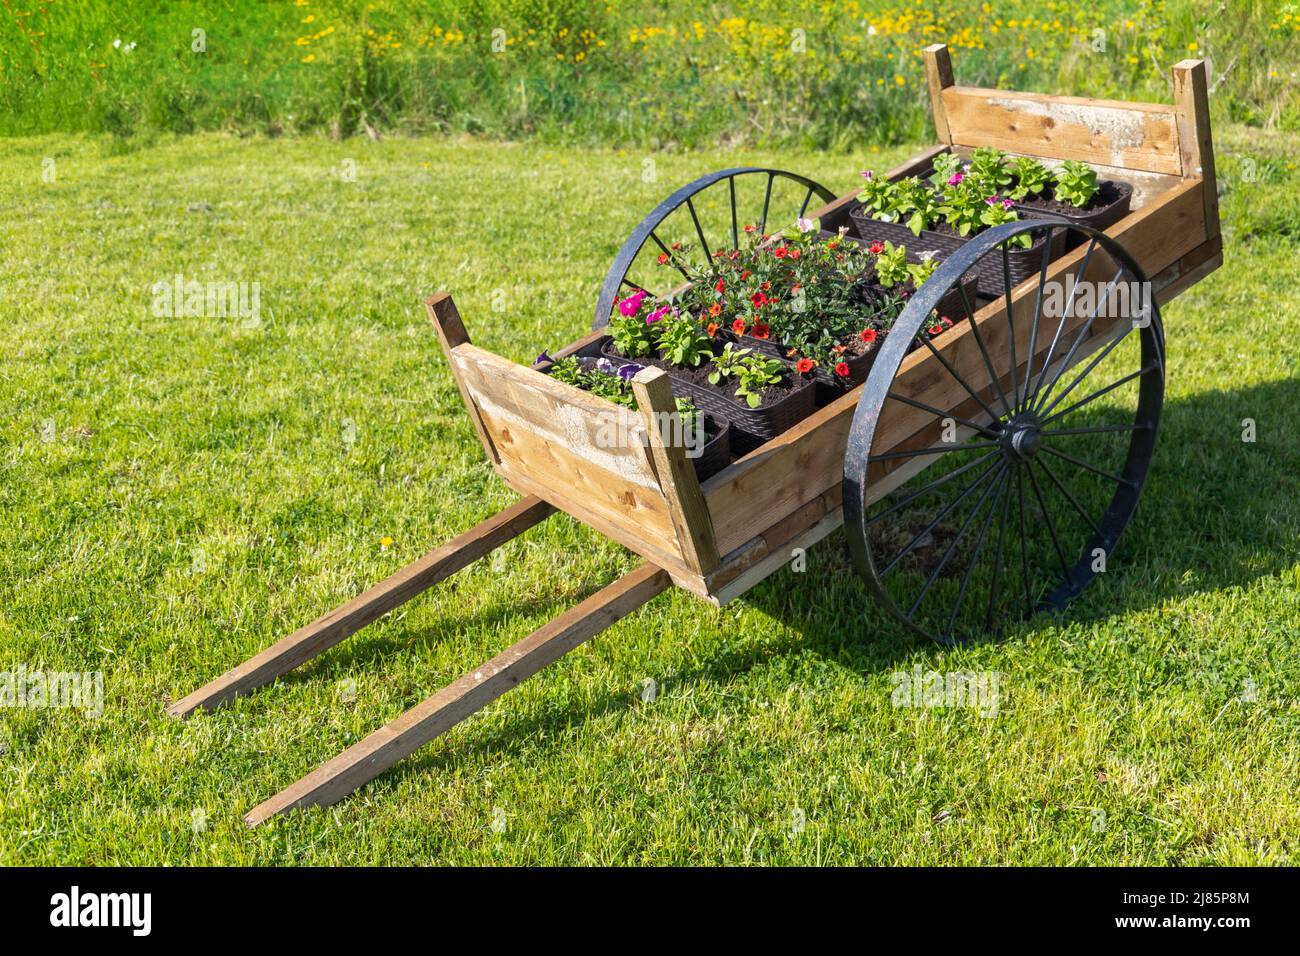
(703, 179), (1206, 555)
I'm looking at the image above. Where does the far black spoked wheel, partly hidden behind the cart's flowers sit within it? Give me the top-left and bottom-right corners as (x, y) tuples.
(592, 166), (835, 329)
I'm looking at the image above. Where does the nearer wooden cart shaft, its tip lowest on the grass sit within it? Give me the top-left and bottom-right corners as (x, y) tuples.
(244, 564), (670, 826)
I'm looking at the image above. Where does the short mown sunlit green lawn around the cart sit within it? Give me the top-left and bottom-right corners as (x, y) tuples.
(0, 129), (1300, 864)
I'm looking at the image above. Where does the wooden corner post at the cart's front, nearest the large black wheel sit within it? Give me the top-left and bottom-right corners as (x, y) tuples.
(632, 368), (719, 575)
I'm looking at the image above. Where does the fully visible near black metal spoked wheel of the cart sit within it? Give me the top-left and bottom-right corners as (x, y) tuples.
(844, 220), (1165, 644)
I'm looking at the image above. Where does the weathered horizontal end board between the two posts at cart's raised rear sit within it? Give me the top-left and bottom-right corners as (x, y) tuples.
(941, 86), (1183, 176)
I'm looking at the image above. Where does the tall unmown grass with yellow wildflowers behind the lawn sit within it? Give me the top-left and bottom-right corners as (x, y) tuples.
(0, 0), (1300, 148)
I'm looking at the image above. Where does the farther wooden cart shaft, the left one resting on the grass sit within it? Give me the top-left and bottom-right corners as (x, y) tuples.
(168, 497), (555, 717)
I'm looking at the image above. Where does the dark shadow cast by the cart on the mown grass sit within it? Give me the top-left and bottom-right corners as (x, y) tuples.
(379, 380), (1300, 780)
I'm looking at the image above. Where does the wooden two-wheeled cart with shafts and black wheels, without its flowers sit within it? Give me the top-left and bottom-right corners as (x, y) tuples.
(170, 46), (1222, 825)
